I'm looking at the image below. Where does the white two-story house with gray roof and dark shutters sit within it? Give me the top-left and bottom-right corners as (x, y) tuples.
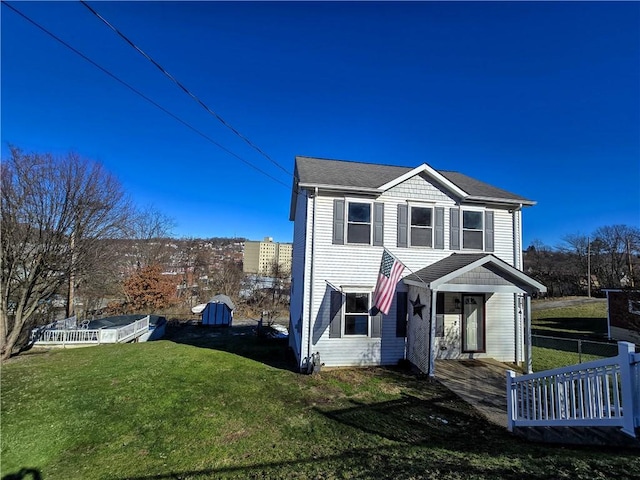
(289, 157), (546, 375)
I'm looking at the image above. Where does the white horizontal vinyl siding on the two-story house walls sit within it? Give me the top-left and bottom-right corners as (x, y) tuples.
(290, 171), (521, 366)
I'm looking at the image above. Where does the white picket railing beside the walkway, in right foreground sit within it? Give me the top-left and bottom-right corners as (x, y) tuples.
(507, 342), (640, 437)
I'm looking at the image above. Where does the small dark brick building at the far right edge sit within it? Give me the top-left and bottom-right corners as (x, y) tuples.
(603, 289), (640, 345)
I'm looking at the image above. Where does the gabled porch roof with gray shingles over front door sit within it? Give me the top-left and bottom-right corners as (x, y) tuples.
(403, 253), (547, 294)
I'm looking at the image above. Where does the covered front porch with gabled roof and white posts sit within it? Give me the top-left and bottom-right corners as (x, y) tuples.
(403, 253), (546, 376)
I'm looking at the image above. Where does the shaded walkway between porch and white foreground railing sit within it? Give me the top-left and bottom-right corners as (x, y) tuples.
(435, 359), (509, 428)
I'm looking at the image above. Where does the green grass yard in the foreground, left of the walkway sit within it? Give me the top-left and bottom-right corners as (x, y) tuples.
(0, 327), (640, 480)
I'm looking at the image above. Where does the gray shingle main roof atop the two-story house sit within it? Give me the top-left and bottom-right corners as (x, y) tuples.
(296, 156), (535, 205)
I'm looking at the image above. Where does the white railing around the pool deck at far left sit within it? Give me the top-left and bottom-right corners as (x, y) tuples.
(32, 315), (149, 345)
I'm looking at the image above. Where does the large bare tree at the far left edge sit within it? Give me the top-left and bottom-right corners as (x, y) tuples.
(0, 147), (131, 359)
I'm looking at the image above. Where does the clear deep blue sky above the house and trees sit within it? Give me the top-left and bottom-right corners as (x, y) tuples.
(1, 2), (640, 246)
